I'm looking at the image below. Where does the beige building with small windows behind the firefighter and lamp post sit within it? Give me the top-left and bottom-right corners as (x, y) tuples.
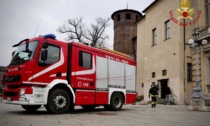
(137, 0), (210, 104)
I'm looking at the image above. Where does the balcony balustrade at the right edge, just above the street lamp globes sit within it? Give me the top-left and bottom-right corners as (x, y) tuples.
(198, 26), (210, 40)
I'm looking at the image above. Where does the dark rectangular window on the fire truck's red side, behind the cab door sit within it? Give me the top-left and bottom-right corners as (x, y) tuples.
(79, 51), (92, 69)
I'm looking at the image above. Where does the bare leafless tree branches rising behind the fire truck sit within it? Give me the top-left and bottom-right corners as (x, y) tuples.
(58, 17), (110, 47)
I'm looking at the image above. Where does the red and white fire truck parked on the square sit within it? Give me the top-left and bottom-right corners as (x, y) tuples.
(1, 34), (136, 114)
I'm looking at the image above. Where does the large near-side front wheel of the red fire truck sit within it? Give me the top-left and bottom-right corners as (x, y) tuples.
(45, 89), (70, 114)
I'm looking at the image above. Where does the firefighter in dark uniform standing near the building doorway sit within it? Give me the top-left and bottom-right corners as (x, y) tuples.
(149, 84), (158, 108)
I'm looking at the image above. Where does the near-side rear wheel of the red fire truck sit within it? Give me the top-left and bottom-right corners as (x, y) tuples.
(110, 93), (123, 111)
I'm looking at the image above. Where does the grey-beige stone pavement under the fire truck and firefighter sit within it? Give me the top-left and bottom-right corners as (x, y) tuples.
(0, 103), (210, 126)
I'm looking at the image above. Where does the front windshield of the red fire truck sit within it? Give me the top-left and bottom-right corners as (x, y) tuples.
(10, 41), (38, 66)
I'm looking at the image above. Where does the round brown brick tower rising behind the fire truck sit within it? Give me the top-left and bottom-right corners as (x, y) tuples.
(111, 9), (142, 57)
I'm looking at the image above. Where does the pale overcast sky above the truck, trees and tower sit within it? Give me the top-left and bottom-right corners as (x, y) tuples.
(0, 0), (154, 66)
